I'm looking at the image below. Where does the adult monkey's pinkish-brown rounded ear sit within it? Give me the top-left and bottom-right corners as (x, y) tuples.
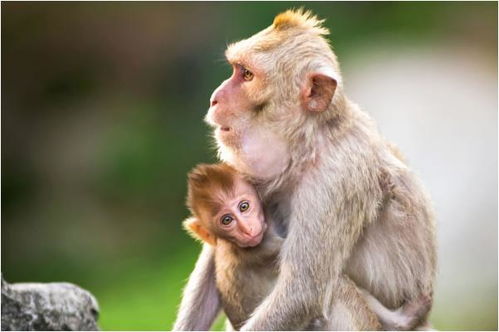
(301, 72), (338, 112)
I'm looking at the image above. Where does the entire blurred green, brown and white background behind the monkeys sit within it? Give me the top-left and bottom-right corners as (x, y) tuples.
(1, 2), (497, 330)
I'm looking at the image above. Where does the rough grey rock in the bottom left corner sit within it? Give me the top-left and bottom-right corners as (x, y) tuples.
(2, 276), (99, 331)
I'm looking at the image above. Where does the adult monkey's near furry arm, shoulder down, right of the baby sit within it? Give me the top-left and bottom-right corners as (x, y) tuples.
(242, 154), (381, 330)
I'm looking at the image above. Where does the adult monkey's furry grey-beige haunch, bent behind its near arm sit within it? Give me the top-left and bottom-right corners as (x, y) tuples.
(345, 184), (436, 329)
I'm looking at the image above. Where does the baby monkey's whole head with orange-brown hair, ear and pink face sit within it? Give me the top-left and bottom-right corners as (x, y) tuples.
(184, 163), (267, 247)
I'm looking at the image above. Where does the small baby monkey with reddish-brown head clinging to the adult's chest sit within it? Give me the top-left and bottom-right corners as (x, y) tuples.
(183, 163), (431, 330)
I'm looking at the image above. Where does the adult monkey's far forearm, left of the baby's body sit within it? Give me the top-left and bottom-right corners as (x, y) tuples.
(173, 244), (221, 331)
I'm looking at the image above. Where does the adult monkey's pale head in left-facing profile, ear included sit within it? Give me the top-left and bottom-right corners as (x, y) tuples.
(205, 20), (340, 180)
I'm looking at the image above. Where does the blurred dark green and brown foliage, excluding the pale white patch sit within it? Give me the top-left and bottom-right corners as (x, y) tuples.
(1, 2), (497, 330)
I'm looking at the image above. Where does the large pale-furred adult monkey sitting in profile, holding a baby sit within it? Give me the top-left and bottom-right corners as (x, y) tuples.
(174, 10), (436, 330)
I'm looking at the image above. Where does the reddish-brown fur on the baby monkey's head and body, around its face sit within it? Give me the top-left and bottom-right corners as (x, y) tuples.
(183, 163), (283, 329)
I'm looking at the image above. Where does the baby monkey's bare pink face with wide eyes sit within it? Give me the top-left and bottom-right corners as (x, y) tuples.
(210, 176), (267, 247)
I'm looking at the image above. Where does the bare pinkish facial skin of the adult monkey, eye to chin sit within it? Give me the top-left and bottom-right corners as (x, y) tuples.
(205, 64), (290, 179)
